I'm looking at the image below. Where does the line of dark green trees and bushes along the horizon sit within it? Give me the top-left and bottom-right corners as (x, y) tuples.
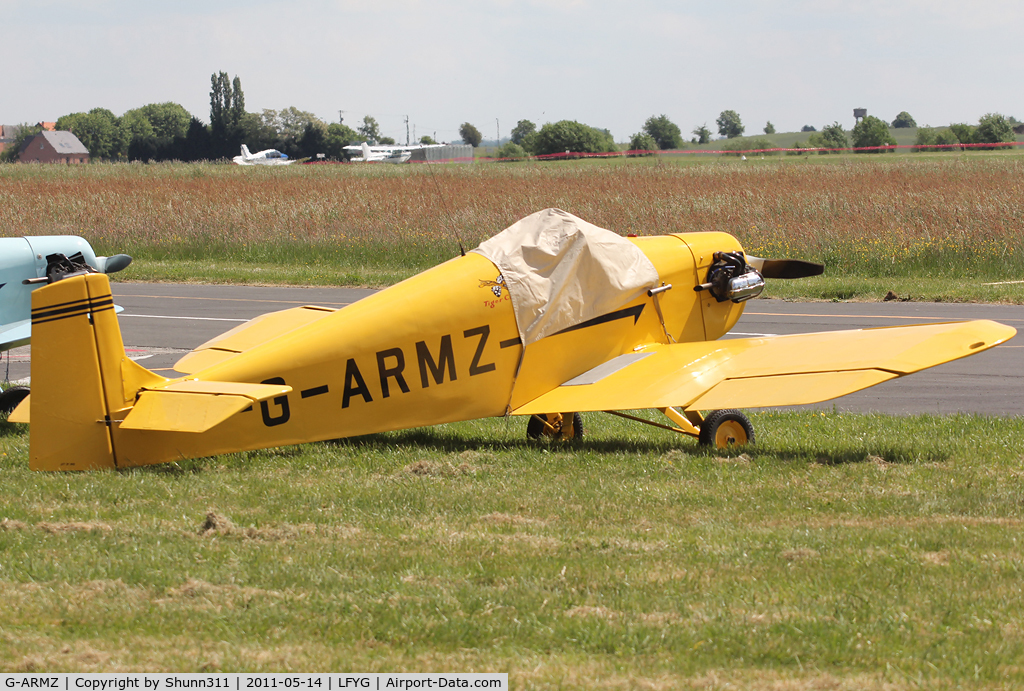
(2, 72), (1018, 161)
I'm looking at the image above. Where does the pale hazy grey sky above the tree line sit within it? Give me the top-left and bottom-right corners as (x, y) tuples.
(0, 0), (1024, 141)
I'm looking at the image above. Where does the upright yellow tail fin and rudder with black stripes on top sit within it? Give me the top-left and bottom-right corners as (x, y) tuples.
(29, 273), (167, 470)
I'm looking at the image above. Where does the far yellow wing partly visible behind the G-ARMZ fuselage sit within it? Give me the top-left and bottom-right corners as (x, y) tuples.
(174, 305), (337, 375)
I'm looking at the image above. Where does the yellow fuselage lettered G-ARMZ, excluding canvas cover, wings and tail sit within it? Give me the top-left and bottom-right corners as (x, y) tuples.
(112, 233), (742, 466)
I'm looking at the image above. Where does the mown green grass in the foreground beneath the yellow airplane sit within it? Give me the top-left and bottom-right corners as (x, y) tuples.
(0, 413), (1024, 689)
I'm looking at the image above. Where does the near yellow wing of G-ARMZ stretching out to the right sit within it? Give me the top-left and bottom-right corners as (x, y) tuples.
(512, 320), (1017, 415)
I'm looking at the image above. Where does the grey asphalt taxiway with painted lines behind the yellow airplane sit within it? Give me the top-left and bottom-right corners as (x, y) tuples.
(0, 283), (1024, 416)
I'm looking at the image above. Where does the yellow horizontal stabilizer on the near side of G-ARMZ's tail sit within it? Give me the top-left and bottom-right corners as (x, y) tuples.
(121, 381), (292, 432)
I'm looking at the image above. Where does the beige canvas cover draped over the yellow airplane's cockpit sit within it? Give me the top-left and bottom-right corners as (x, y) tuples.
(473, 209), (658, 345)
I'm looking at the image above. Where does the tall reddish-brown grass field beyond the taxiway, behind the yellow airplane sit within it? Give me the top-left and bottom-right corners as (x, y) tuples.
(0, 156), (1024, 277)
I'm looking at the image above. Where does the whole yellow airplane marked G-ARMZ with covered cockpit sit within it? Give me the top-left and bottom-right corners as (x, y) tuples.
(9, 209), (1016, 470)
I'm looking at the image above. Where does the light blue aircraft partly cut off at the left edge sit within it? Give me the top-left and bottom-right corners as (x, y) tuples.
(0, 235), (131, 414)
